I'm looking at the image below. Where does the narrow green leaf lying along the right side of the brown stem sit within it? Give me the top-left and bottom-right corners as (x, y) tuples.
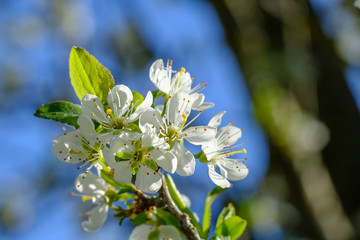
(165, 175), (205, 238)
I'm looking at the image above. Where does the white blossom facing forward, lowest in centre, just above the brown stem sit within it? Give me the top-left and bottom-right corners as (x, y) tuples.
(104, 124), (177, 193)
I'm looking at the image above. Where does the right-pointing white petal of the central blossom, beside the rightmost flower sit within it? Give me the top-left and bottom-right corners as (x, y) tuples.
(183, 126), (216, 145)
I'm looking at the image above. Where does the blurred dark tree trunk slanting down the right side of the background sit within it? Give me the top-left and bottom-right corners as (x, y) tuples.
(210, 0), (360, 239)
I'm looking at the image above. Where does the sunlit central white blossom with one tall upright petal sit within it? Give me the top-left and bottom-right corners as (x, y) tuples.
(139, 92), (216, 176)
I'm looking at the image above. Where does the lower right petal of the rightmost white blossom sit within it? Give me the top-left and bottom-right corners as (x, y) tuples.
(218, 158), (249, 181)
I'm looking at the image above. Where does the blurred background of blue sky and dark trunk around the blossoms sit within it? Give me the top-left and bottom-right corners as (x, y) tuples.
(0, 0), (360, 240)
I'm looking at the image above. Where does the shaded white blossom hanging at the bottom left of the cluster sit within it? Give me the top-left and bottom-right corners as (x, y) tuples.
(74, 173), (109, 231)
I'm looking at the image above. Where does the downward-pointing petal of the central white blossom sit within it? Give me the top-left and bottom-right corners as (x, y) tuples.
(171, 142), (195, 176)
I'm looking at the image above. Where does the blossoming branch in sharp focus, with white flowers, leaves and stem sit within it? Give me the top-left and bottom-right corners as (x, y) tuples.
(35, 47), (248, 240)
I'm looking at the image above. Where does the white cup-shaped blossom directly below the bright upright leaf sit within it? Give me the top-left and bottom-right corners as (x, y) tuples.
(81, 85), (153, 133)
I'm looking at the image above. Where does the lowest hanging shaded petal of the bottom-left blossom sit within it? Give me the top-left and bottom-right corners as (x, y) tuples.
(82, 204), (109, 232)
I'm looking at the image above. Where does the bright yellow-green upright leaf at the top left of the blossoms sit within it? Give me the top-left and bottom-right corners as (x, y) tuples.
(69, 47), (115, 104)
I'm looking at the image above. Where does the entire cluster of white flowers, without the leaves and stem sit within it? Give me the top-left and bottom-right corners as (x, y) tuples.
(52, 60), (248, 233)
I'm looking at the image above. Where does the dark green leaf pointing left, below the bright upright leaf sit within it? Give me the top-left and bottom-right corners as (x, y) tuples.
(34, 101), (82, 128)
